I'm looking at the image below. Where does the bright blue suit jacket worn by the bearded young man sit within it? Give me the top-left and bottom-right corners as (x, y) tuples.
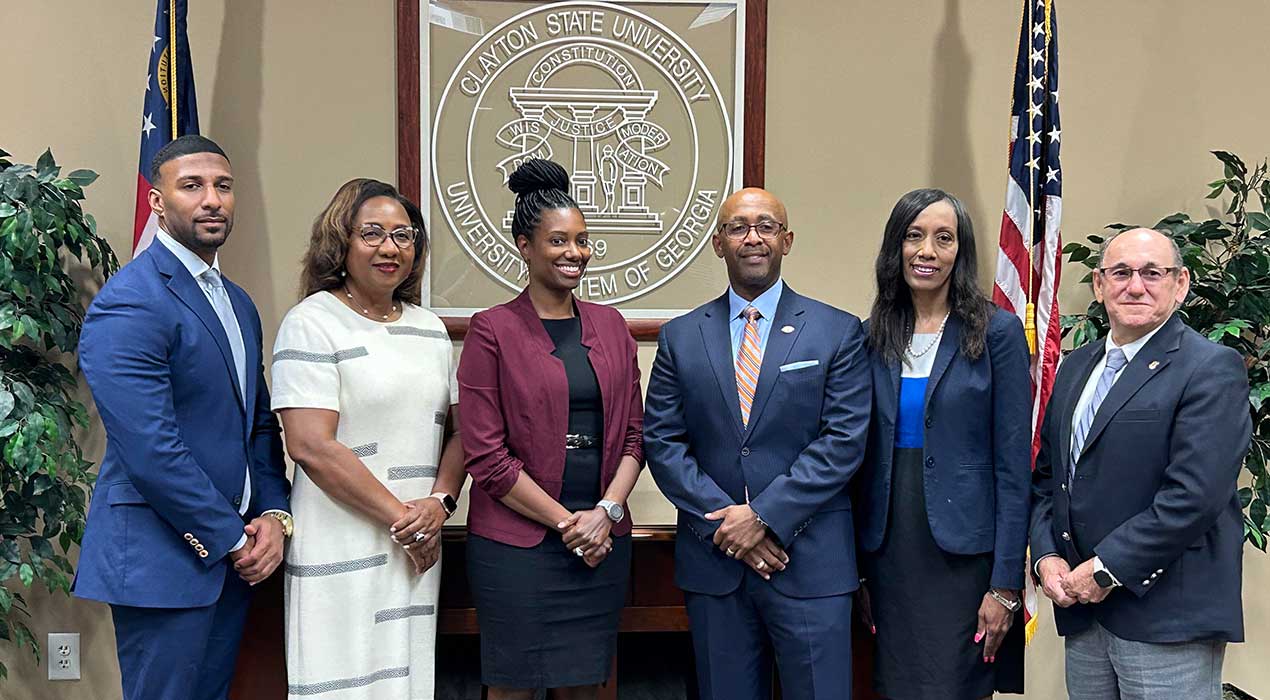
(75, 243), (290, 607)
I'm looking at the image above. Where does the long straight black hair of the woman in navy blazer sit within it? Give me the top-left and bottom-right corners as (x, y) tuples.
(869, 188), (992, 365)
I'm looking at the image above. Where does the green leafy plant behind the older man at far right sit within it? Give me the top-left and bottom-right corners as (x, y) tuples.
(1062, 151), (1270, 551)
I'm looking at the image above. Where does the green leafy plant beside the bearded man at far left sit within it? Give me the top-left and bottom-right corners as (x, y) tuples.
(0, 150), (119, 680)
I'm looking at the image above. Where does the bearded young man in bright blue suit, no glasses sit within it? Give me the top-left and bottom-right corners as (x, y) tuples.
(75, 136), (291, 700)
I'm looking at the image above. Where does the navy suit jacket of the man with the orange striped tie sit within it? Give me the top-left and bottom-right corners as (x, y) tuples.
(644, 286), (870, 597)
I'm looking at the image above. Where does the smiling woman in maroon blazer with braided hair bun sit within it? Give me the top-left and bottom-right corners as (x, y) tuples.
(458, 159), (644, 700)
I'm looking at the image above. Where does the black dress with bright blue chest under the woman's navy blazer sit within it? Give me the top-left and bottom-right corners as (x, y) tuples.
(865, 377), (1024, 700)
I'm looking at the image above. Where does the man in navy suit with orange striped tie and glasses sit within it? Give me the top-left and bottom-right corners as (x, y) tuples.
(644, 188), (871, 700)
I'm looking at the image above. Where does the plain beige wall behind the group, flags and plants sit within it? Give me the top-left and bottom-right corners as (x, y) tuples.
(0, 0), (1270, 700)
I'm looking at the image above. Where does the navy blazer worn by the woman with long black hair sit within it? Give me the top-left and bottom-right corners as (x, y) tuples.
(856, 306), (1031, 589)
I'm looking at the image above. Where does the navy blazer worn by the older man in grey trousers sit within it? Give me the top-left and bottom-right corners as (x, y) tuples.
(1031, 315), (1252, 643)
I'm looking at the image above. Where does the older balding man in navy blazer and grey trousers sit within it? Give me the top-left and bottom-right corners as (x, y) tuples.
(1031, 229), (1252, 700)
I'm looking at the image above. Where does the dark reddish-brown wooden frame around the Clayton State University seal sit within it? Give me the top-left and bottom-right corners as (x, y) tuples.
(396, 0), (767, 340)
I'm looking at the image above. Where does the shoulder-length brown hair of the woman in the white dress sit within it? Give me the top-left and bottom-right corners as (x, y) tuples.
(300, 178), (428, 305)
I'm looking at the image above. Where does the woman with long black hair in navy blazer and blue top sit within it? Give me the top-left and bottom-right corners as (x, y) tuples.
(857, 189), (1031, 700)
